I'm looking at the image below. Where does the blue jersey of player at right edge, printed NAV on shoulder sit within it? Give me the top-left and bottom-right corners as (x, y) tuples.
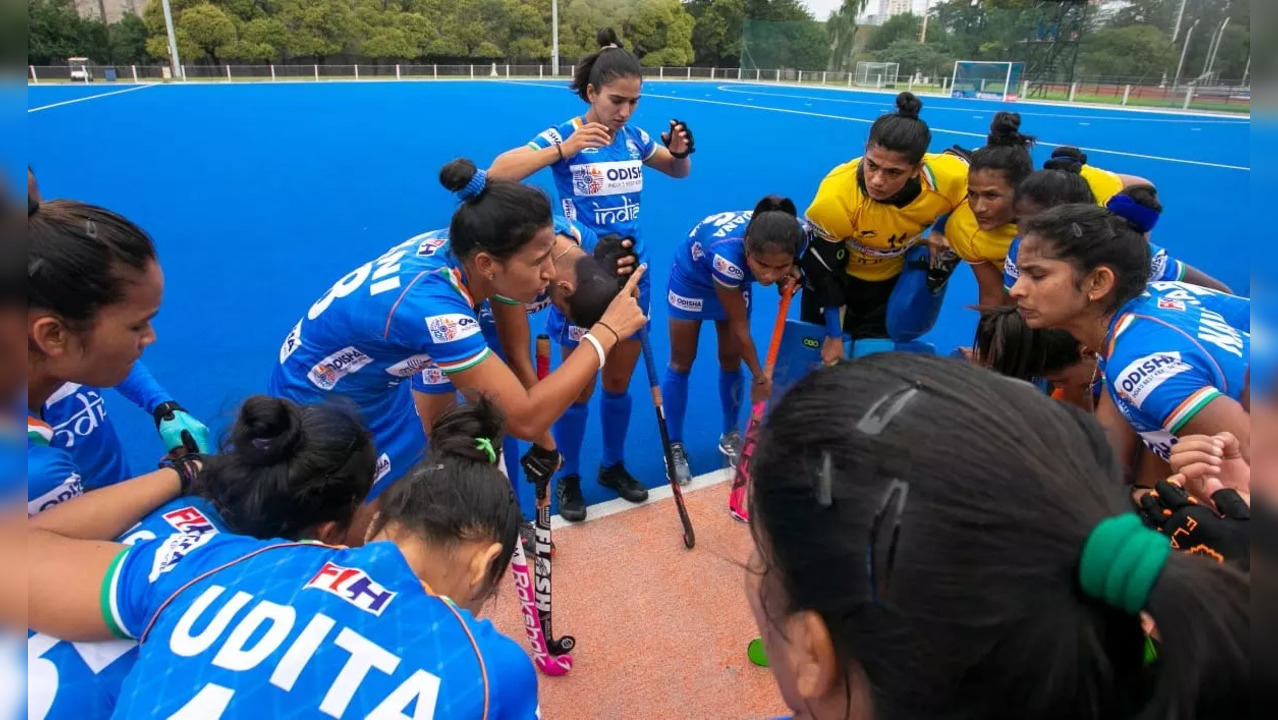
(1100, 283), (1251, 460)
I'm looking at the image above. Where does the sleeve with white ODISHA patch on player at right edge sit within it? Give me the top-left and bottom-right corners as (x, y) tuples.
(1105, 315), (1223, 435)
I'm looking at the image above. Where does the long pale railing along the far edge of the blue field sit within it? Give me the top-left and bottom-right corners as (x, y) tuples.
(27, 63), (1251, 113)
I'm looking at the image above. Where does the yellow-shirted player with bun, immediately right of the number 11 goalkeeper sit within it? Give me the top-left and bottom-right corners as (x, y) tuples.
(943, 113), (1035, 307)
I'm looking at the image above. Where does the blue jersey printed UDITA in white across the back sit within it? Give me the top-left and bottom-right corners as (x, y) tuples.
(102, 533), (538, 720)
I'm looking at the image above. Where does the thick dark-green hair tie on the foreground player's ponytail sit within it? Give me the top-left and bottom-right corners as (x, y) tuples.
(1079, 513), (1172, 615)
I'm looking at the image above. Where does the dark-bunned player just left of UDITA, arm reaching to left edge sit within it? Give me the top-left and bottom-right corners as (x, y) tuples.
(27, 395), (377, 720)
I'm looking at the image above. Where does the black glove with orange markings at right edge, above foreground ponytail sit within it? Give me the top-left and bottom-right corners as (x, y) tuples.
(1140, 480), (1251, 569)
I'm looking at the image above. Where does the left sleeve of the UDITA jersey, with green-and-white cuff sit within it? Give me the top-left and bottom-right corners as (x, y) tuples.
(100, 532), (245, 639)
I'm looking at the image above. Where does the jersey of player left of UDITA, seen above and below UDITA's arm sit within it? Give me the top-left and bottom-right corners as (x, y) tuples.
(27, 496), (226, 720)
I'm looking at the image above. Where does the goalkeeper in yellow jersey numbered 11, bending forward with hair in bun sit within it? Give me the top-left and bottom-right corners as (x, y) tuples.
(801, 92), (967, 363)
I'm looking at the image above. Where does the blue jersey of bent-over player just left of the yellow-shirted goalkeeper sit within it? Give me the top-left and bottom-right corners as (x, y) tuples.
(671, 211), (754, 292)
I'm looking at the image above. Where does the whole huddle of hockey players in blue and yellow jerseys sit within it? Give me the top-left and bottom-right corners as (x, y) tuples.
(22, 25), (1247, 719)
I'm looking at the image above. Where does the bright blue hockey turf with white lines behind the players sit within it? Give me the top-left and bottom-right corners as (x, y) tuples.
(24, 81), (1252, 516)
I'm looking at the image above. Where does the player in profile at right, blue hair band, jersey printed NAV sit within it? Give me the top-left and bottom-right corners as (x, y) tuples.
(1011, 205), (1251, 460)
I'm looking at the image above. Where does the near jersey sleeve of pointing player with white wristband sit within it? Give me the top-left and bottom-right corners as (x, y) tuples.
(390, 269), (491, 375)
